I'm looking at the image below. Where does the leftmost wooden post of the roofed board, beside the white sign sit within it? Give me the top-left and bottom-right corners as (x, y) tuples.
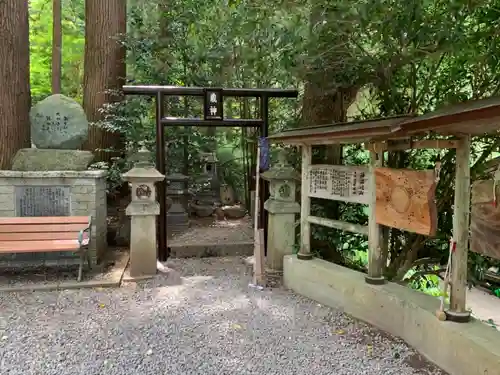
(297, 145), (312, 260)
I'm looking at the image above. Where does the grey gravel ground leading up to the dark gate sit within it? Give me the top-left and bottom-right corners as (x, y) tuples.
(0, 258), (443, 375)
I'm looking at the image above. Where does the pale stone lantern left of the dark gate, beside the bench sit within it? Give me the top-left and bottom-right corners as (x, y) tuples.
(122, 147), (165, 278)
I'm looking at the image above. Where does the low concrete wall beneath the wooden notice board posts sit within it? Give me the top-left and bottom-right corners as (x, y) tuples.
(284, 255), (500, 375)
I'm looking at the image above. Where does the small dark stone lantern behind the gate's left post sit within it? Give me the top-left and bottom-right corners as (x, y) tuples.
(167, 173), (189, 233)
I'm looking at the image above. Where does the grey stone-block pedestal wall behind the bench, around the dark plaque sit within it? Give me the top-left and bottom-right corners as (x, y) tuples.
(0, 171), (107, 266)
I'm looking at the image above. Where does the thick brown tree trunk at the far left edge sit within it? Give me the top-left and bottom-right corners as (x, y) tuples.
(0, 0), (31, 170)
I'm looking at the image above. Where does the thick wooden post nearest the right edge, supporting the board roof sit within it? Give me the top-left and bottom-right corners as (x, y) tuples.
(446, 135), (471, 323)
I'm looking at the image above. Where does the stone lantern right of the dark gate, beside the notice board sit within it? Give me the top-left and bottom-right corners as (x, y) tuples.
(261, 151), (300, 271)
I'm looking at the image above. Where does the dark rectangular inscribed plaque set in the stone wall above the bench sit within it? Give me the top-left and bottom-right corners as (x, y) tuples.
(15, 186), (71, 217)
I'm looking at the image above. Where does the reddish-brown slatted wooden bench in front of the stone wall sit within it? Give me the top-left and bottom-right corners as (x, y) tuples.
(0, 216), (92, 281)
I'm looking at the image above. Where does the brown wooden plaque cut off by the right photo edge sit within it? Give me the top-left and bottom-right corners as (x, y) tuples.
(470, 180), (500, 259)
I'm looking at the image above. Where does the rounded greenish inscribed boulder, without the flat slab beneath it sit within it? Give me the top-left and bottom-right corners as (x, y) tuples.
(30, 94), (89, 150)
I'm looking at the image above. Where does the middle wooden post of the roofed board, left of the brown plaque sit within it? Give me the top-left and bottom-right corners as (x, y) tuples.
(365, 144), (385, 285)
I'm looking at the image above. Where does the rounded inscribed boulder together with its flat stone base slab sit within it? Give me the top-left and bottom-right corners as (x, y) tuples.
(12, 94), (94, 171)
